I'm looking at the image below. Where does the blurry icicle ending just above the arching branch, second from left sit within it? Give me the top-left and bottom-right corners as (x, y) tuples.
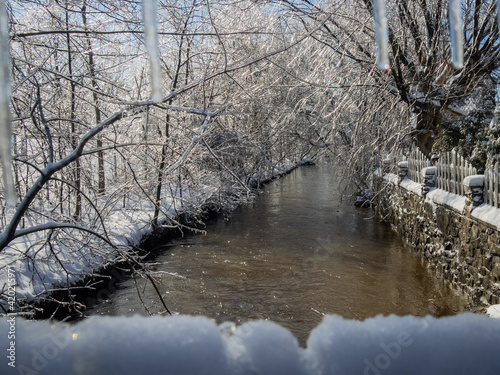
(142, 0), (162, 102)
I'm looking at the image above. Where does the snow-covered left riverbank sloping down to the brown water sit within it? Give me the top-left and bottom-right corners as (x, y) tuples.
(0, 158), (313, 315)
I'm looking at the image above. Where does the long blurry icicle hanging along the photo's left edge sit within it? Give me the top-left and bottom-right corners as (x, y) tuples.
(0, 0), (17, 206)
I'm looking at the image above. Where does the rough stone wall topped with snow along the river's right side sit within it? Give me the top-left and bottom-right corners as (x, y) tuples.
(375, 175), (500, 305)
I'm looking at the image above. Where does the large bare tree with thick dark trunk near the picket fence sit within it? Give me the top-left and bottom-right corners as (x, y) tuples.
(281, 0), (500, 154)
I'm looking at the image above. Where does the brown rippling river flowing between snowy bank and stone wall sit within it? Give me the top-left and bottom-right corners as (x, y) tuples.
(86, 164), (467, 343)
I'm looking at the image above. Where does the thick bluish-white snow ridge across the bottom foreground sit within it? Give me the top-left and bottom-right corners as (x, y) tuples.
(0, 314), (500, 375)
